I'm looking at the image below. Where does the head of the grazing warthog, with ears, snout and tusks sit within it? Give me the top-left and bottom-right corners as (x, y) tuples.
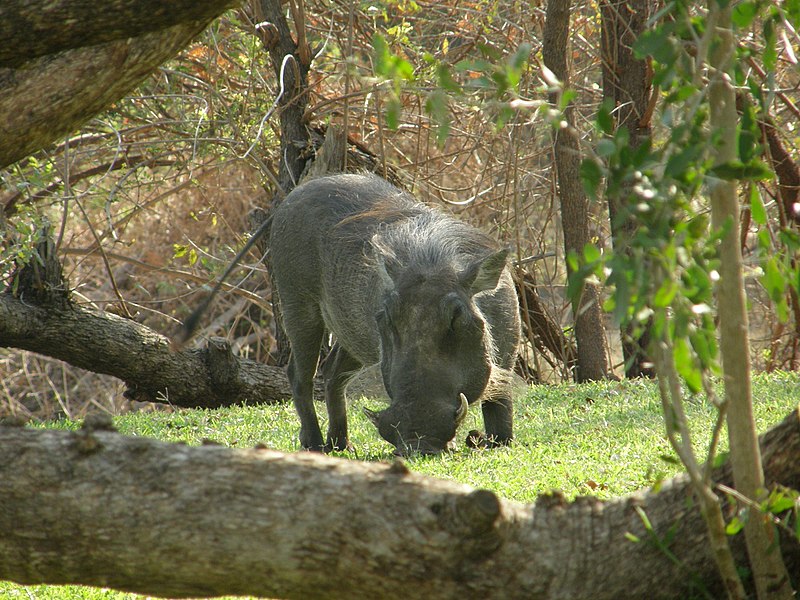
(365, 241), (507, 455)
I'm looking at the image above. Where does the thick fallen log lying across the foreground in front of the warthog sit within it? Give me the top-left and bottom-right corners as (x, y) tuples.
(0, 412), (800, 600)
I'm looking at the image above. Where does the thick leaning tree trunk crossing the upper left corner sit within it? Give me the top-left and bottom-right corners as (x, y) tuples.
(0, 0), (238, 168)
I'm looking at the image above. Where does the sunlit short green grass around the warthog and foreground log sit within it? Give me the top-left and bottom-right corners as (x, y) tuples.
(0, 373), (800, 600)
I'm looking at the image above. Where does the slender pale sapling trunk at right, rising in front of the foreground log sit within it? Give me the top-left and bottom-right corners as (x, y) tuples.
(708, 1), (793, 600)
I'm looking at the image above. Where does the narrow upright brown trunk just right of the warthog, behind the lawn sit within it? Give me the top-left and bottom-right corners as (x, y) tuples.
(542, 0), (608, 381)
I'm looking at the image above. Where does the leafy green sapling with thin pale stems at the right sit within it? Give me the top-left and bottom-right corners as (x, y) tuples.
(570, 2), (797, 598)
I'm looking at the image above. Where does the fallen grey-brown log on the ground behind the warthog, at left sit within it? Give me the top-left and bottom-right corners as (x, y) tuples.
(0, 294), (308, 408)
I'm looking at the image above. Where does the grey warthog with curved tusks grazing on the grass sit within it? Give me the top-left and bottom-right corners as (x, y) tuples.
(270, 175), (520, 454)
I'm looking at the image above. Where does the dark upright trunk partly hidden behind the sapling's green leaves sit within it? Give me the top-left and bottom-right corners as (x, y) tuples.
(600, 0), (655, 377)
